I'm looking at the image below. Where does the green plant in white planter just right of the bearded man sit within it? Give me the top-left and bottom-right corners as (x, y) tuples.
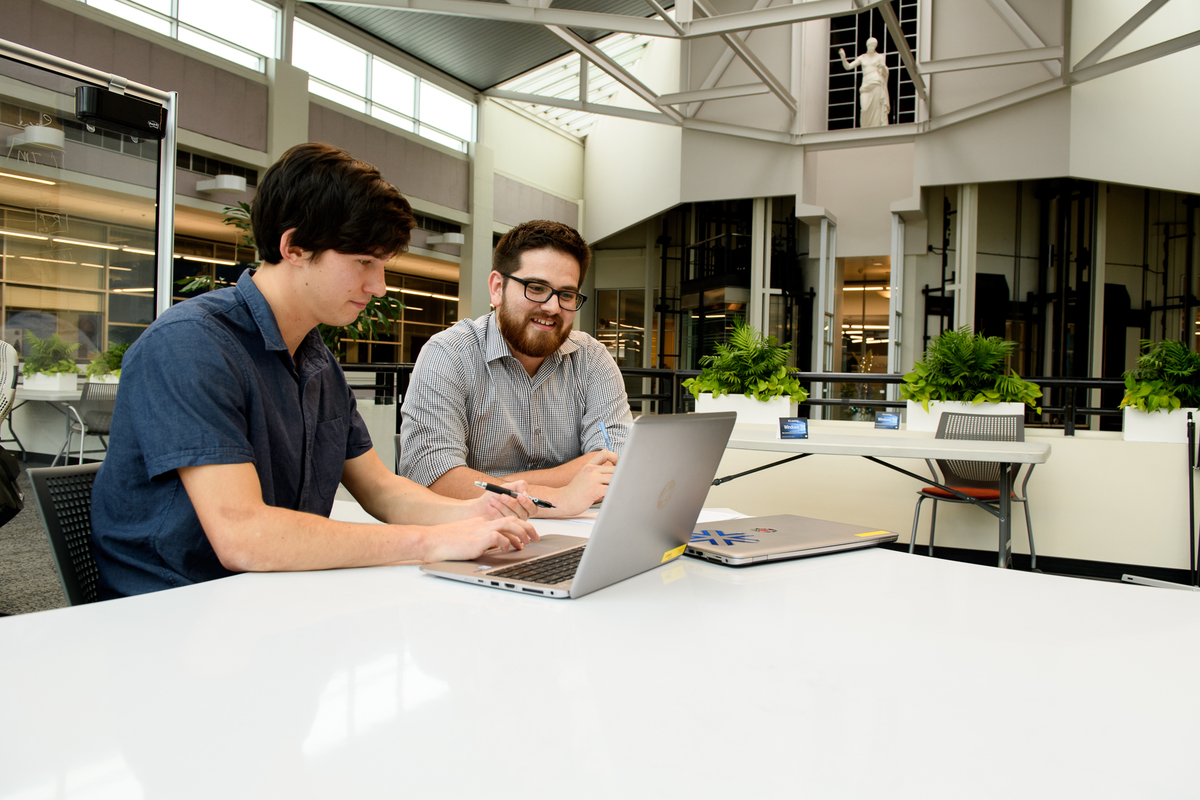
(682, 320), (809, 425)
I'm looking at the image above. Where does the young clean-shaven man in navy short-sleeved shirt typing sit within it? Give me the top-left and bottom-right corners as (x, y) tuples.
(91, 144), (536, 599)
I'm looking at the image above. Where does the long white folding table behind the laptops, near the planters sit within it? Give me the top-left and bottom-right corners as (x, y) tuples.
(718, 427), (1050, 569)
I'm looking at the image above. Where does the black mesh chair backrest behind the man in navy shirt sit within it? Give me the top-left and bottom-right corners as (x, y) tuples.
(26, 463), (100, 606)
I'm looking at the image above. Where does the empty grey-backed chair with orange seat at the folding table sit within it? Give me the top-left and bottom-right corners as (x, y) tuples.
(908, 411), (1038, 570)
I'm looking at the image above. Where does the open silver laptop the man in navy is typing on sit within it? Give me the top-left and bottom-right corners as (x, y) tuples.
(421, 411), (737, 597)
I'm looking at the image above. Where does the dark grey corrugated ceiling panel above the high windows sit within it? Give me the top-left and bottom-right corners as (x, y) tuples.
(314, 0), (673, 91)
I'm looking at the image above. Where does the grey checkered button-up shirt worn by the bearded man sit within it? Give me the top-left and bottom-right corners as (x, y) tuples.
(400, 312), (634, 486)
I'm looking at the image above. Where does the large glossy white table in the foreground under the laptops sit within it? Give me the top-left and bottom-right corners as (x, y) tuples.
(0, 520), (1200, 800)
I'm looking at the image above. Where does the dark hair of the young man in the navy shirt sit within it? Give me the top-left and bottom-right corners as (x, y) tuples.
(250, 143), (415, 264)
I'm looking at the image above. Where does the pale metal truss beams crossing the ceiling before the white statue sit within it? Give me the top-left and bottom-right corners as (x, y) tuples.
(308, 0), (1200, 146)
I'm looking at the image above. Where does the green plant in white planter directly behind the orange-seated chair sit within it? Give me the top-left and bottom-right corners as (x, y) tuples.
(900, 326), (1042, 431)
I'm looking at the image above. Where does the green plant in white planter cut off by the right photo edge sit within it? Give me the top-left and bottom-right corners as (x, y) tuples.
(1121, 339), (1200, 443)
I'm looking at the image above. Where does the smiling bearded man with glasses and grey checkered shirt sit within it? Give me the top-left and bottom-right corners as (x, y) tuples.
(400, 219), (632, 516)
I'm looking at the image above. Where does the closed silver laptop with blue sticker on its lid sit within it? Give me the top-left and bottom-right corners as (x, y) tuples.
(686, 513), (896, 566)
